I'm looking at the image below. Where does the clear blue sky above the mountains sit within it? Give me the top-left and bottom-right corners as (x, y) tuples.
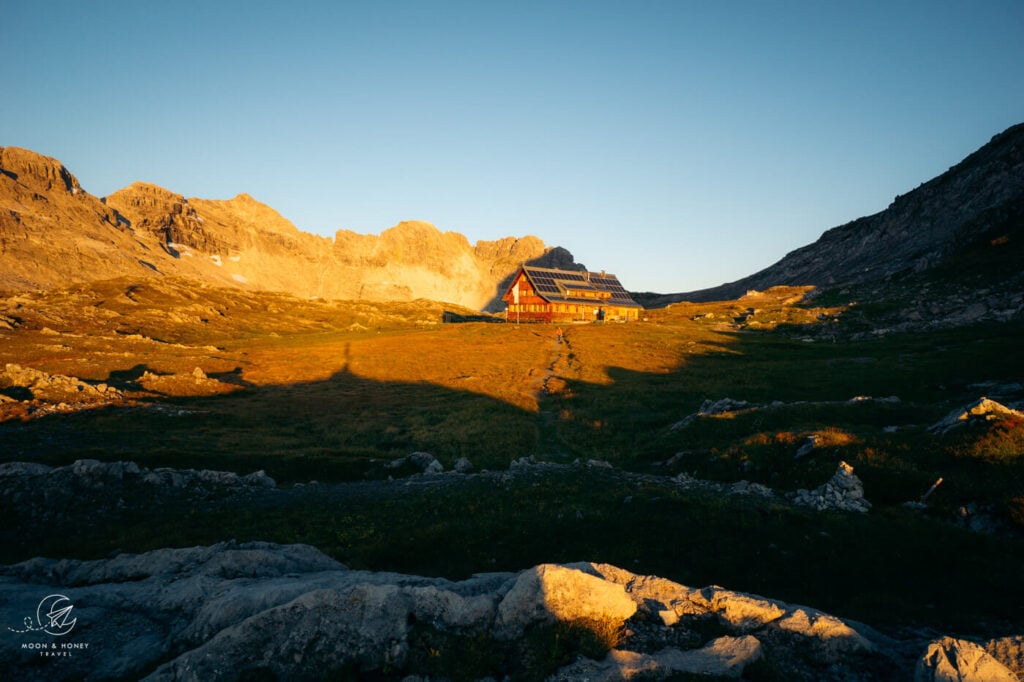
(0, 0), (1024, 292)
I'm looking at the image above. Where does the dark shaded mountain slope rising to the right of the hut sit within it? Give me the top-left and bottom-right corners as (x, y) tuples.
(671, 124), (1024, 303)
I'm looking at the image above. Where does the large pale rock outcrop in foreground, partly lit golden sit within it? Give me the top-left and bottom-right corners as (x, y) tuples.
(0, 543), (1021, 680)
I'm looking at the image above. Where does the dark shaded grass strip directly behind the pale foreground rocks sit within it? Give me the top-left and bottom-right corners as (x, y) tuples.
(5, 467), (1024, 633)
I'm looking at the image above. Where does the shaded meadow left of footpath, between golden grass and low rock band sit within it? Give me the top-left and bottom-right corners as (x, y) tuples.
(0, 358), (537, 483)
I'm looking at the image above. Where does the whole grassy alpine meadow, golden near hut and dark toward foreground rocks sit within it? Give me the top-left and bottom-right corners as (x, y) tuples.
(0, 282), (1024, 633)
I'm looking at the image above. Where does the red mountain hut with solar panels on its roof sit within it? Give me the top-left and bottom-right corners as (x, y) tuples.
(502, 265), (643, 323)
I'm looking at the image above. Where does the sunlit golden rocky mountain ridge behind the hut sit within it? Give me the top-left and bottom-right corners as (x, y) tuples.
(0, 147), (580, 309)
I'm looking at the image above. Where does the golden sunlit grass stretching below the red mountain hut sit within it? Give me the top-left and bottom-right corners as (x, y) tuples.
(0, 281), (839, 419)
